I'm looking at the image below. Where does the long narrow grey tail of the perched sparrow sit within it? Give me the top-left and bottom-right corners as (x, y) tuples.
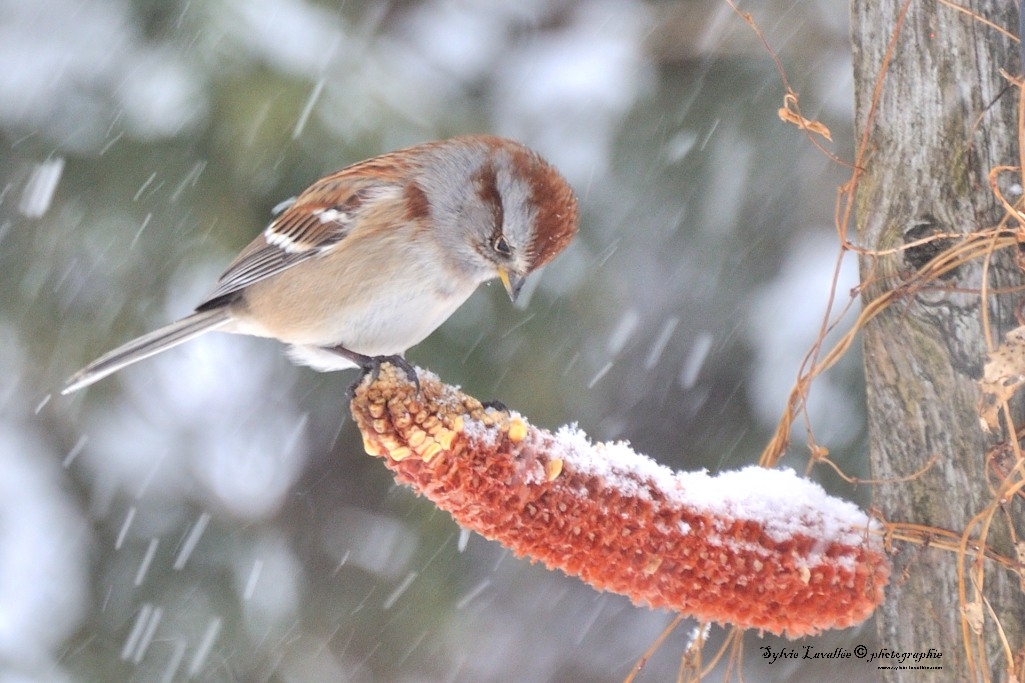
(60, 308), (230, 394)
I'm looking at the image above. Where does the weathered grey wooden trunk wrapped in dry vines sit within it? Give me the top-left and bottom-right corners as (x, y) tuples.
(852, 0), (1025, 683)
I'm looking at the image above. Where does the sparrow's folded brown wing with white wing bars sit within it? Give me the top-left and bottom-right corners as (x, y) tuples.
(196, 160), (402, 311)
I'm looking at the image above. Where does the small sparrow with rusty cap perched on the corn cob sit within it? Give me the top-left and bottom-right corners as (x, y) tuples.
(62, 135), (577, 394)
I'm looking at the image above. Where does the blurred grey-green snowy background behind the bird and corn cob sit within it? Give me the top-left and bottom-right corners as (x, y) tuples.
(0, 0), (874, 683)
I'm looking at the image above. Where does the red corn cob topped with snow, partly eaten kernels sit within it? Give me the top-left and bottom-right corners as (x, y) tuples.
(352, 365), (890, 638)
